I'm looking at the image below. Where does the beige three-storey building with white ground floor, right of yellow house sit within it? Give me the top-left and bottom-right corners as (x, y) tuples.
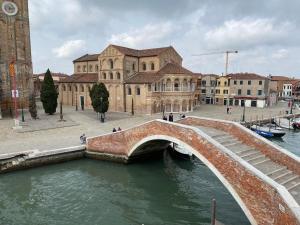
(227, 73), (270, 108)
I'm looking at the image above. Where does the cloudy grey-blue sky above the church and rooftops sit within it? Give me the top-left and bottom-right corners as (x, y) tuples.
(29, 0), (300, 77)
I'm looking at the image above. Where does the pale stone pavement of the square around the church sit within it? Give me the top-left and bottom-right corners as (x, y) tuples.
(0, 101), (299, 154)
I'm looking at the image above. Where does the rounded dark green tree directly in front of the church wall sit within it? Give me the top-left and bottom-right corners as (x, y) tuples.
(90, 83), (109, 122)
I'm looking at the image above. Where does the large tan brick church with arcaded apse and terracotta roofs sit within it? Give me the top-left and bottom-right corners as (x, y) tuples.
(59, 45), (197, 114)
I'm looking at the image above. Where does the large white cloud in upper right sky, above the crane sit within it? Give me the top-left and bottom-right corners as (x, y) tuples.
(205, 18), (291, 49)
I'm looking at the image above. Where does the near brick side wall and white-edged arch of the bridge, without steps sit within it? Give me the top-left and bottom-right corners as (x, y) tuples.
(87, 118), (300, 225)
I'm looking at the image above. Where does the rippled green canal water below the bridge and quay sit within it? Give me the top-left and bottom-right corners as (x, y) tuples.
(0, 132), (300, 225)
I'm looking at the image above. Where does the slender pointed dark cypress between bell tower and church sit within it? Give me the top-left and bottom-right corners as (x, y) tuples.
(41, 69), (58, 115)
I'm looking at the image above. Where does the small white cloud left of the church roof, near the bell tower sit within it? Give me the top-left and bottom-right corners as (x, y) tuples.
(53, 40), (86, 58)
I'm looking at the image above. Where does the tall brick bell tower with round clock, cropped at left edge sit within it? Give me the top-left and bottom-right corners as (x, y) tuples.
(0, 0), (33, 118)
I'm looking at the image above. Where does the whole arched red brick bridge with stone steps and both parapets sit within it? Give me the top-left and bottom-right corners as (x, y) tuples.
(87, 117), (300, 225)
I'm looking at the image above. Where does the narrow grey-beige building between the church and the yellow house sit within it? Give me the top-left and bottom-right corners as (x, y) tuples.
(200, 74), (219, 104)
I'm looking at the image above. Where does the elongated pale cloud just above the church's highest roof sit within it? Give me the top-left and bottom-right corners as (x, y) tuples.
(109, 22), (175, 48)
